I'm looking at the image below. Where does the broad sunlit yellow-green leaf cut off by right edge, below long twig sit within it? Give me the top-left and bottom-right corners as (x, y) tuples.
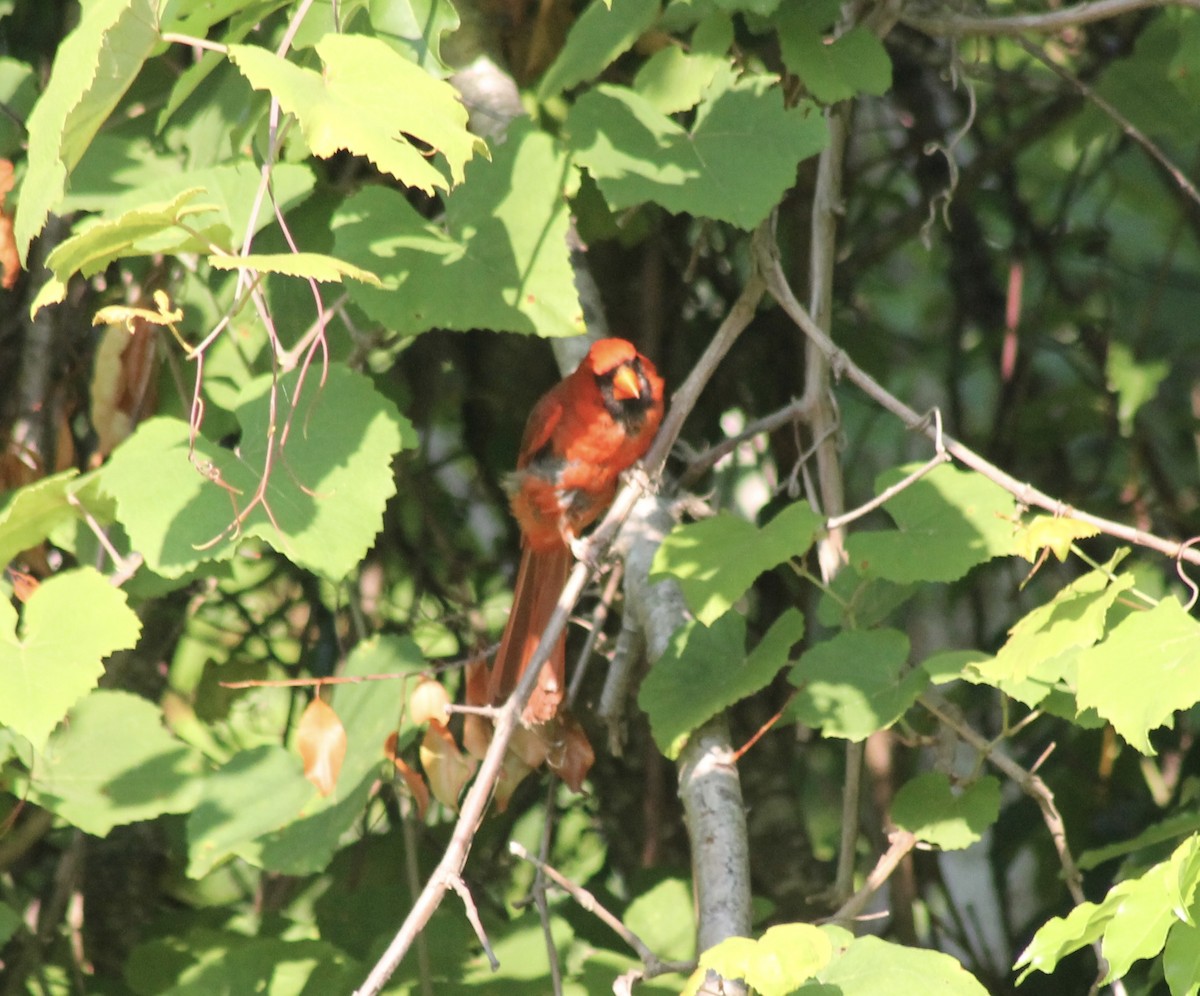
(1078, 598), (1200, 755)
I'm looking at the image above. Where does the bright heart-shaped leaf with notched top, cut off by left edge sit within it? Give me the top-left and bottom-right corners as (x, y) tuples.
(0, 568), (142, 750)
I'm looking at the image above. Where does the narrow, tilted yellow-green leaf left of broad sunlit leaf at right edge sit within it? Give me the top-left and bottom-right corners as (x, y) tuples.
(974, 564), (1134, 690)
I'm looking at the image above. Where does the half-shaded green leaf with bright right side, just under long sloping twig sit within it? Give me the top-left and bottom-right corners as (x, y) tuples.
(846, 464), (1015, 583)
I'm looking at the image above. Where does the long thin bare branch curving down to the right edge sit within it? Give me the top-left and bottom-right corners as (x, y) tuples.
(758, 235), (1200, 573)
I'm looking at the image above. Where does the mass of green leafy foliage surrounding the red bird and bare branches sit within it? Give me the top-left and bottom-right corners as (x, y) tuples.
(0, 0), (1200, 994)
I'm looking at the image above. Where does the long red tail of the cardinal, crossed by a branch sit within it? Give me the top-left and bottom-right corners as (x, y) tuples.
(488, 544), (571, 724)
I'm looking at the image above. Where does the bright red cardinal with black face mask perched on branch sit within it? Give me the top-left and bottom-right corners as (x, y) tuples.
(488, 338), (662, 724)
